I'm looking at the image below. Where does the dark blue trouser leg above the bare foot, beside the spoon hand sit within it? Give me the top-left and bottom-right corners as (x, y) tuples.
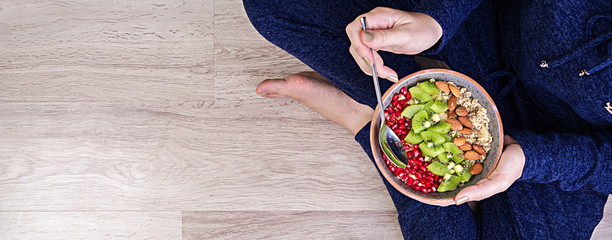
(243, 0), (420, 108)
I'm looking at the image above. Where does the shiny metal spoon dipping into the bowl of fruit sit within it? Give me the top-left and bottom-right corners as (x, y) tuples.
(361, 17), (408, 168)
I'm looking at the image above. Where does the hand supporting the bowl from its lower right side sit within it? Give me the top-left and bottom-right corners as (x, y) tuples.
(455, 136), (525, 205)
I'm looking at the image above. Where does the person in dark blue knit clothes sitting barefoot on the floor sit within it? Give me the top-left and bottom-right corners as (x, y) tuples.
(244, 0), (612, 239)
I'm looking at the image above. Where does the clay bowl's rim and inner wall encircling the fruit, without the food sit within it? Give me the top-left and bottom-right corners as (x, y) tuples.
(370, 69), (504, 206)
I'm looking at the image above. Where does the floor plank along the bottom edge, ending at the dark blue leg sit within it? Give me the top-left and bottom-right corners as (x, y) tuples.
(183, 211), (402, 240)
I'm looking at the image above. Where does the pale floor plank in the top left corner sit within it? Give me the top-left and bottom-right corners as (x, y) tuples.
(0, 0), (213, 102)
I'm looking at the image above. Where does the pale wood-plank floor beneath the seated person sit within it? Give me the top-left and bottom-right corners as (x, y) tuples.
(0, 0), (612, 239)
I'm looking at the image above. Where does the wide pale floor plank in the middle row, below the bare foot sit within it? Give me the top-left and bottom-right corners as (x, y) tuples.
(0, 102), (392, 211)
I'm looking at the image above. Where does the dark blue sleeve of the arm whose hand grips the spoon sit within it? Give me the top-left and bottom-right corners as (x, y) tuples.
(412, 0), (482, 55)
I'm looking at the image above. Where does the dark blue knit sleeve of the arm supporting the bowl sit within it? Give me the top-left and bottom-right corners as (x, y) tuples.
(511, 132), (612, 194)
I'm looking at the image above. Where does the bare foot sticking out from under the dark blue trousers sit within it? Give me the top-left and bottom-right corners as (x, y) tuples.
(255, 72), (374, 135)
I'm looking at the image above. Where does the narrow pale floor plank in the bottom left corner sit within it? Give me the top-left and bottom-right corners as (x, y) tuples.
(0, 211), (182, 240)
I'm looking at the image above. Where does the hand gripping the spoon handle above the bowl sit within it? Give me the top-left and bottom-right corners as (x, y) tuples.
(346, 7), (442, 82)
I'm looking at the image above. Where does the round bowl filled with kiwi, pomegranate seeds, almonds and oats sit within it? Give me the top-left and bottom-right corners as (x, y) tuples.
(370, 69), (504, 206)
